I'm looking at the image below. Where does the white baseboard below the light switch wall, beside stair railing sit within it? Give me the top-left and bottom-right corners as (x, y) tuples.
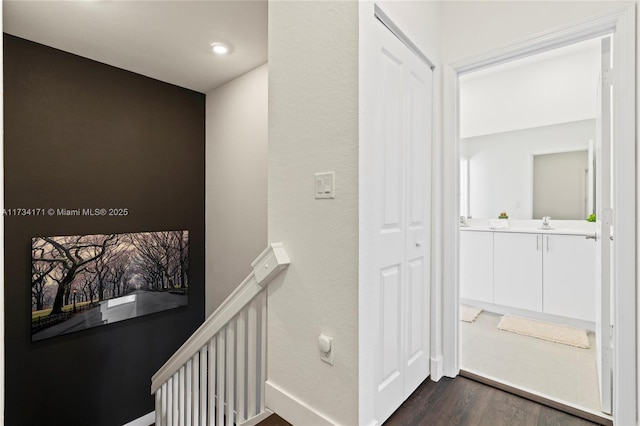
(265, 381), (336, 426)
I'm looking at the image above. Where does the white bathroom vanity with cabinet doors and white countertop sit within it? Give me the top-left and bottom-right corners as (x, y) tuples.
(459, 221), (596, 326)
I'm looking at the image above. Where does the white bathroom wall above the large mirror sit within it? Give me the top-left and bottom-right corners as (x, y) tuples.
(460, 40), (601, 138)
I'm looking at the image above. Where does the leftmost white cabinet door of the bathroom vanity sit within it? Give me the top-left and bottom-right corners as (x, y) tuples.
(460, 231), (493, 303)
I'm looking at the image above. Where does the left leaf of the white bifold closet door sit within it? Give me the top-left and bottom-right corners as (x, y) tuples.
(374, 28), (406, 418)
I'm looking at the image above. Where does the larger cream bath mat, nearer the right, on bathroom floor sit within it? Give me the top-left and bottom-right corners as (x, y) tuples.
(498, 315), (589, 349)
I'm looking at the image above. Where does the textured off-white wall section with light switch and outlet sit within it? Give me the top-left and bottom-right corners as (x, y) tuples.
(266, 1), (358, 425)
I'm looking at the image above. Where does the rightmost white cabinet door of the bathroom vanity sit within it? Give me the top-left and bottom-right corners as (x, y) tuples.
(543, 235), (596, 321)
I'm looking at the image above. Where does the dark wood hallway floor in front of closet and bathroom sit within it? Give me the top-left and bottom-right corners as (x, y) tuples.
(260, 377), (596, 426)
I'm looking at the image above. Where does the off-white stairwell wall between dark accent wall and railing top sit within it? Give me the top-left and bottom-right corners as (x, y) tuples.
(205, 64), (268, 316)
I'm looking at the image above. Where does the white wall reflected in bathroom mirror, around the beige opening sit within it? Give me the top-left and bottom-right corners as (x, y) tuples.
(460, 120), (596, 219)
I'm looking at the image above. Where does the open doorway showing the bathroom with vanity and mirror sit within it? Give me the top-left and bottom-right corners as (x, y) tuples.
(458, 34), (613, 419)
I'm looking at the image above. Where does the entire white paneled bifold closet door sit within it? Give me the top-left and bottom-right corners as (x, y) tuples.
(371, 16), (432, 423)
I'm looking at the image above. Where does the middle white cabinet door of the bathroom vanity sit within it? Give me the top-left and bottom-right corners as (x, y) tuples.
(493, 232), (542, 312)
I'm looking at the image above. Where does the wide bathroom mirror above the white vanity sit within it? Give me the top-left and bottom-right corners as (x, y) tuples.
(460, 119), (595, 220)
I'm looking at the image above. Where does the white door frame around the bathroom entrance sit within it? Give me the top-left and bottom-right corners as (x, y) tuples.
(436, 4), (639, 424)
